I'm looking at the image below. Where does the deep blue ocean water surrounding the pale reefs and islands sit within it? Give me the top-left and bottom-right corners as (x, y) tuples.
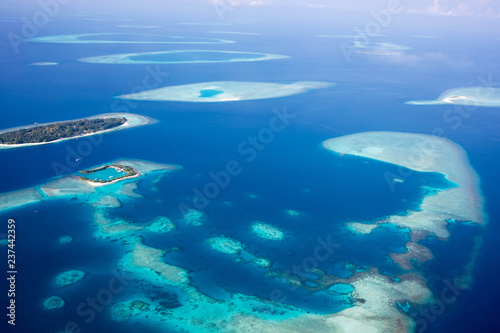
(0, 6), (500, 332)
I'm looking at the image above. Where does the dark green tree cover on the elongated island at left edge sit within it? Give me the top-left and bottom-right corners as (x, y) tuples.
(0, 117), (127, 145)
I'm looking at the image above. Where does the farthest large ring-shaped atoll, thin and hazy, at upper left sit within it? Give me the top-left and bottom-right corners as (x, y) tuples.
(28, 32), (234, 44)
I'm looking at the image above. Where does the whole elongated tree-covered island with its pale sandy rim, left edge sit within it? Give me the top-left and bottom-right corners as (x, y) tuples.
(0, 113), (157, 149)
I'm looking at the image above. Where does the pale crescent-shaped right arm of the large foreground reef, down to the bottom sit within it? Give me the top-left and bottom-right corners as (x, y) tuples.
(316, 132), (487, 332)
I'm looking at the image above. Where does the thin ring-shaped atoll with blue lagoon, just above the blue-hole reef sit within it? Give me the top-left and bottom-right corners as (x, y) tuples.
(78, 50), (289, 64)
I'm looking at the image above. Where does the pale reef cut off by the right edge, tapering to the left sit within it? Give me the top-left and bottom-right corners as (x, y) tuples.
(406, 87), (500, 107)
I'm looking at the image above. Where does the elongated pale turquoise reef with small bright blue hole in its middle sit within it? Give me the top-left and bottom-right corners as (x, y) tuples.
(116, 81), (333, 102)
